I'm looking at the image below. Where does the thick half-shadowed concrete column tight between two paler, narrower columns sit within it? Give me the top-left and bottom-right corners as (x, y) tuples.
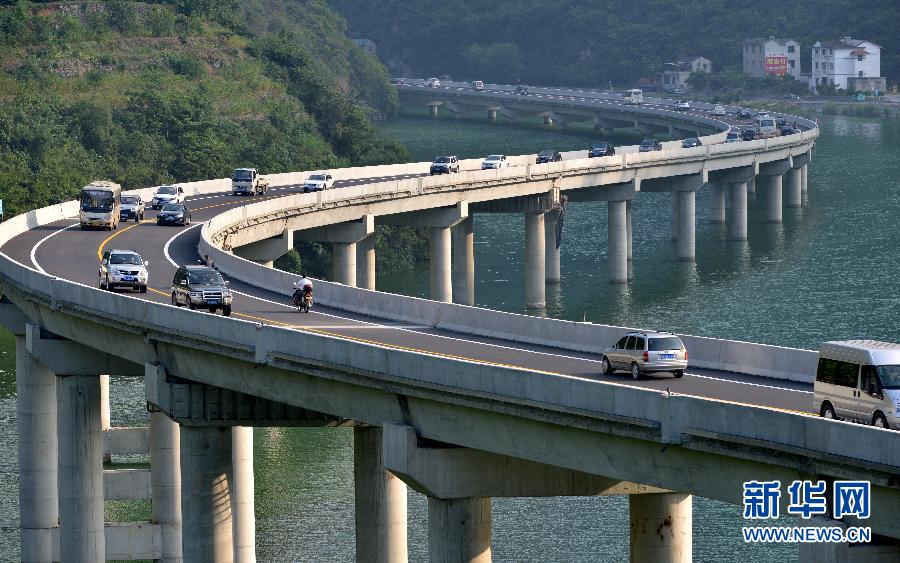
(181, 426), (234, 563)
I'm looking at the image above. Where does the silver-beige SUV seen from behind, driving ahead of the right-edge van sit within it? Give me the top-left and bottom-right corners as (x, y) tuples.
(602, 331), (687, 379)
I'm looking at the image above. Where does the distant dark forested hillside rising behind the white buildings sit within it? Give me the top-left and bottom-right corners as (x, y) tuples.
(328, 0), (900, 86)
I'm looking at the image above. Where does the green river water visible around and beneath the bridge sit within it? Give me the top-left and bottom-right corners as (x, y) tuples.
(0, 112), (900, 562)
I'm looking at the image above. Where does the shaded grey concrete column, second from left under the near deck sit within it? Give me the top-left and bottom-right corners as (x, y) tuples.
(57, 375), (106, 561)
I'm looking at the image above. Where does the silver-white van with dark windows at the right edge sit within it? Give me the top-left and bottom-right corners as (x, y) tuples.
(813, 340), (900, 428)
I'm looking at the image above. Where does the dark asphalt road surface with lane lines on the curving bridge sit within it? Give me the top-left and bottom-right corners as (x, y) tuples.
(2, 88), (812, 412)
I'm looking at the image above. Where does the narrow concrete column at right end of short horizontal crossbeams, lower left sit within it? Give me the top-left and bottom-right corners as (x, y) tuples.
(150, 412), (182, 563)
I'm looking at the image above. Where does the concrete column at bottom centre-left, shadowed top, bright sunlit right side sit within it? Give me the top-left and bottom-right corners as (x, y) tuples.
(353, 426), (408, 563)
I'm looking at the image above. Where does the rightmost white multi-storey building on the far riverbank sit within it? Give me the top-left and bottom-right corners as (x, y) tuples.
(810, 37), (884, 91)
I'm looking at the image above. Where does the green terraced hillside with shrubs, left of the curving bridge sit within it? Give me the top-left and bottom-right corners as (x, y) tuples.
(0, 0), (406, 216)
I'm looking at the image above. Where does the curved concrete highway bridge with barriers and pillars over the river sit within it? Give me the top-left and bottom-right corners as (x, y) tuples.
(0, 80), (900, 561)
